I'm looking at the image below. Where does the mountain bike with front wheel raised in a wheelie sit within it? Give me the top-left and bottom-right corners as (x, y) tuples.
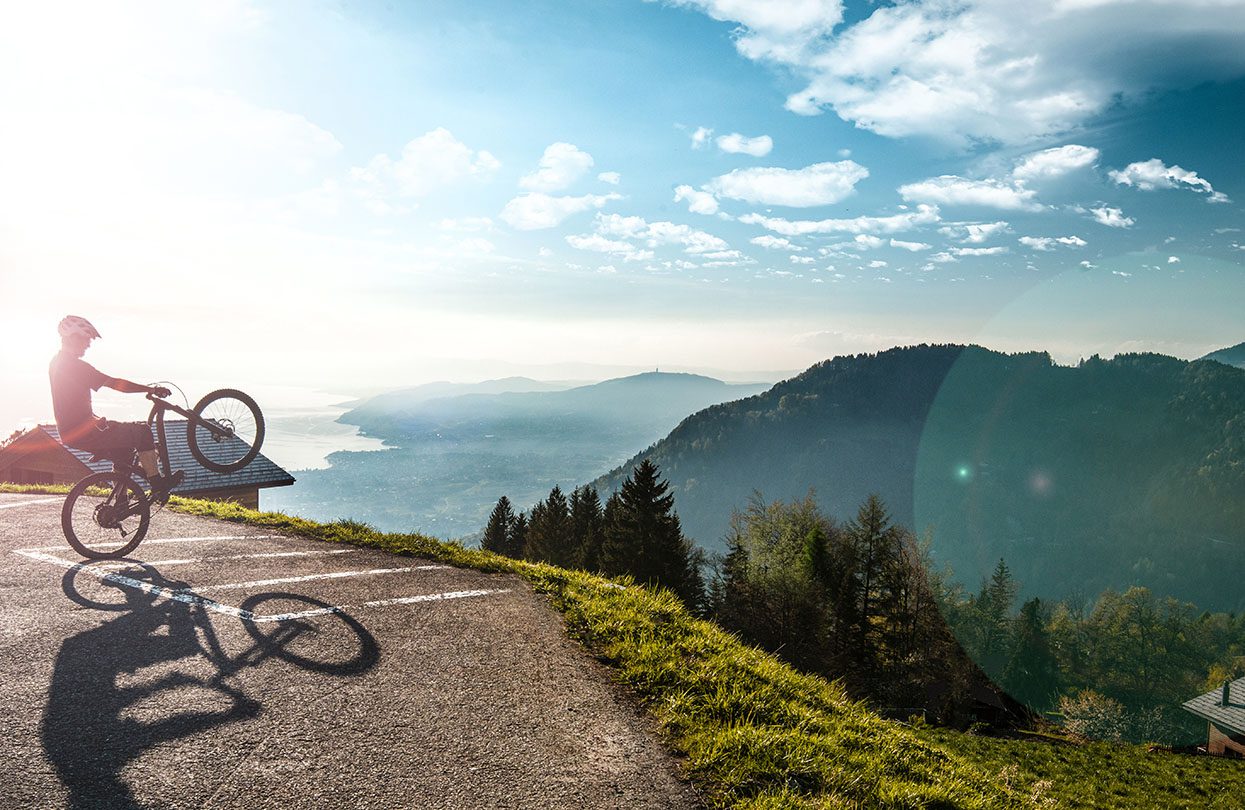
(61, 388), (264, 559)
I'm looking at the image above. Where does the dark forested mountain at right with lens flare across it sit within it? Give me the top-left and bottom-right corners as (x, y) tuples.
(596, 346), (1245, 610)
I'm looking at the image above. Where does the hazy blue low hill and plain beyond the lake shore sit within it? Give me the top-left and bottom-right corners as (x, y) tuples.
(268, 372), (768, 538)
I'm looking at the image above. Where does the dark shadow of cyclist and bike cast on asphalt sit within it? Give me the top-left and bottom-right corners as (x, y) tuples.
(41, 564), (380, 809)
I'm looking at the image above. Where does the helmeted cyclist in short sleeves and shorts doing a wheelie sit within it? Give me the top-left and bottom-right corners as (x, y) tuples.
(47, 315), (186, 500)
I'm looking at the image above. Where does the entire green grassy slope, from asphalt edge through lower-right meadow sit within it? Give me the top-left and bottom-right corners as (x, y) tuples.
(9, 484), (1245, 809)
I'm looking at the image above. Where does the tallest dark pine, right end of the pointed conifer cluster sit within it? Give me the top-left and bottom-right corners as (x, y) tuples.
(601, 459), (705, 607)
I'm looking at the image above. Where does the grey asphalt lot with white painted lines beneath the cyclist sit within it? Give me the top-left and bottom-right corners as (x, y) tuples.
(0, 494), (697, 810)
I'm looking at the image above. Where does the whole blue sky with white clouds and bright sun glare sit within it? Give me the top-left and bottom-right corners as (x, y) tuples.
(0, 0), (1245, 432)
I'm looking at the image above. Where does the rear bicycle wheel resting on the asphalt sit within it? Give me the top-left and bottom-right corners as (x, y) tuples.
(61, 472), (152, 560)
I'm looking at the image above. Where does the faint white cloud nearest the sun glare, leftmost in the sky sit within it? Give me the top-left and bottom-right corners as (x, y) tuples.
(350, 127), (502, 197)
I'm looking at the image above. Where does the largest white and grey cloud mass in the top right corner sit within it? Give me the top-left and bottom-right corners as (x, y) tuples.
(674, 0), (1245, 144)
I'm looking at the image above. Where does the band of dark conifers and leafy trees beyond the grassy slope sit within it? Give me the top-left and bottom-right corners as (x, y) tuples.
(483, 460), (1245, 745)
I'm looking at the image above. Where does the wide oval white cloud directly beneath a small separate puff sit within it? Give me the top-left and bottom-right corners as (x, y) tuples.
(705, 161), (869, 208)
